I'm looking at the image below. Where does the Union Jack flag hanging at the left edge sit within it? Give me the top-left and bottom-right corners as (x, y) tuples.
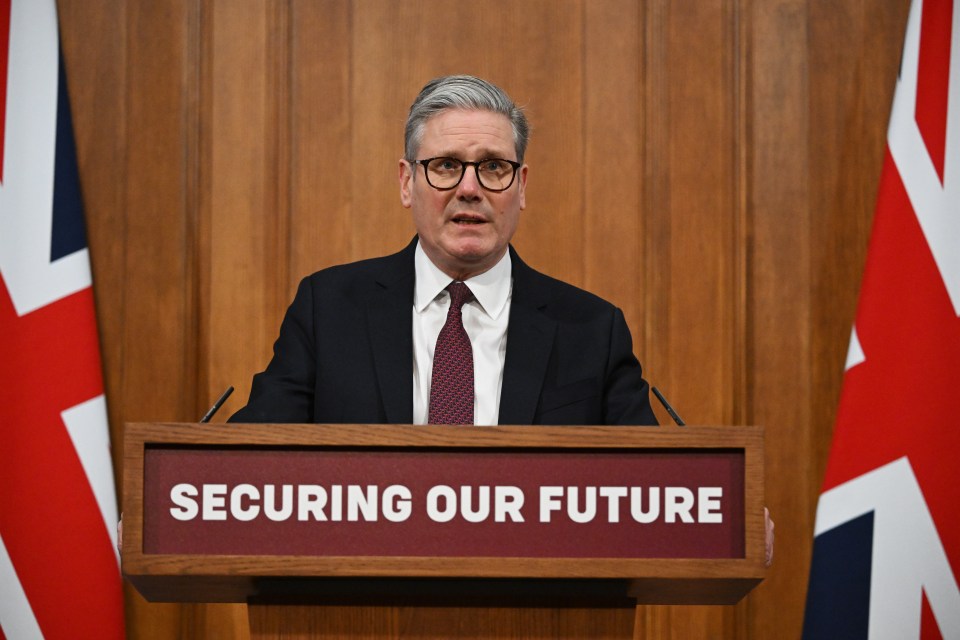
(0, 0), (124, 640)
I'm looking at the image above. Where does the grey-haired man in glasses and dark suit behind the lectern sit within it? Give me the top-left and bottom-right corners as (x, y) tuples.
(231, 76), (656, 425)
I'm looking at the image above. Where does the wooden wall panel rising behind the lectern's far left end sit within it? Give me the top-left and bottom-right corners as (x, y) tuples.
(123, 2), (198, 638)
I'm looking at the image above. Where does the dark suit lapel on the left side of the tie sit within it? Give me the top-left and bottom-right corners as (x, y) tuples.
(367, 240), (416, 424)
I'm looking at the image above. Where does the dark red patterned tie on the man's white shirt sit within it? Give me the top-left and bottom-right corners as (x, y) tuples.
(429, 282), (473, 424)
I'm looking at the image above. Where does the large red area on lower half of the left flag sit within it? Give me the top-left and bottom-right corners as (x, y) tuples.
(0, 279), (123, 638)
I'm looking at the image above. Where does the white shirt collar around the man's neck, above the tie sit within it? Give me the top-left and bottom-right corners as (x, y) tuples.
(413, 242), (513, 319)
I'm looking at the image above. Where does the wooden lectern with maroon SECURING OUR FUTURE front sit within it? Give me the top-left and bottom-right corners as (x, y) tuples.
(122, 423), (765, 638)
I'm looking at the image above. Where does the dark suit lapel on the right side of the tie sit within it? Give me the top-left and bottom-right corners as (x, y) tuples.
(498, 247), (557, 425)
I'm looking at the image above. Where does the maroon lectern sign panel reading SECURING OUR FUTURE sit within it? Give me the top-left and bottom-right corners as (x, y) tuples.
(143, 448), (744, 558)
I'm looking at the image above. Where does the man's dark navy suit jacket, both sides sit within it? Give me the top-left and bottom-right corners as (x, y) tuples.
(231, 240), (657, 425)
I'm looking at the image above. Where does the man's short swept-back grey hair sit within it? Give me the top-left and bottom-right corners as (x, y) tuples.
(403, 76), (530, 163)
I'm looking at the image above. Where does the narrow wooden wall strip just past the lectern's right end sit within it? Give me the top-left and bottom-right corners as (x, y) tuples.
(748, 0), (814, 637)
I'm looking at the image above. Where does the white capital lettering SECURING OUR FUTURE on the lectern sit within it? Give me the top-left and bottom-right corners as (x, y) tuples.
(169, 483), (724, 524)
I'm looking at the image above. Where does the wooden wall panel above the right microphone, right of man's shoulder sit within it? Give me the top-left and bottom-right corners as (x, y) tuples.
(645, 1), (743, 639)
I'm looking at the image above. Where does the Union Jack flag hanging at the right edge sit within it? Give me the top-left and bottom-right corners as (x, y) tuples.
(803, 0), (960, 640)
